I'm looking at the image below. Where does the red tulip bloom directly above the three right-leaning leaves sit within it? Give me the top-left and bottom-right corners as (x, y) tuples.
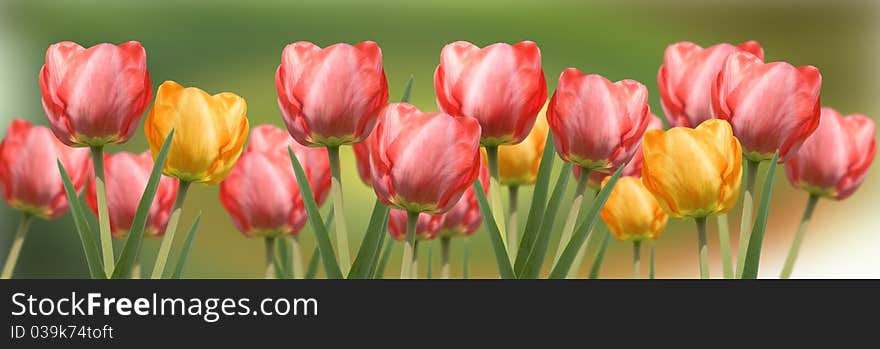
(547, 68), (650, 172)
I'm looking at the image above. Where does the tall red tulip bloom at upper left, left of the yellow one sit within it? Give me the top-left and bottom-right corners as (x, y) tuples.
(40, 41), (153, 146)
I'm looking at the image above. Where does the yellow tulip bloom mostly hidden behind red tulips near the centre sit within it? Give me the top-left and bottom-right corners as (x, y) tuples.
(498, 103), (549, 185)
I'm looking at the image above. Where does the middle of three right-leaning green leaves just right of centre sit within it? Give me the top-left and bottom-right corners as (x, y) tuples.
(519, 162), (572, 279)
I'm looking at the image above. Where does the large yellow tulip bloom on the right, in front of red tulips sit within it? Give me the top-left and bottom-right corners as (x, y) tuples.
(642, 119), (742, 218)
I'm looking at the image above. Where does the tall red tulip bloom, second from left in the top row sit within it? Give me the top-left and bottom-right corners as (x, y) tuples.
(275, 41), (388, 147)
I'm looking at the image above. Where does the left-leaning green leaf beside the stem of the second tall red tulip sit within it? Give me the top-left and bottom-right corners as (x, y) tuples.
(287, 148), (344, 279)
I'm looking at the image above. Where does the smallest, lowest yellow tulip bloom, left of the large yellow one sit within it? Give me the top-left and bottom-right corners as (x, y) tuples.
(601, 177), (669, 241)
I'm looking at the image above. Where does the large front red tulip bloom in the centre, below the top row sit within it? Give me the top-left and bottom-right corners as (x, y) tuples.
(370, 103), (480, 214)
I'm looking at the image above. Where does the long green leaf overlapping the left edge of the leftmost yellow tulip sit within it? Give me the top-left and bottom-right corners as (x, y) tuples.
(113, 129), (174, 279)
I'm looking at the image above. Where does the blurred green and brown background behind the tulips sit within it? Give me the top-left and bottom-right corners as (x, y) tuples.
(0, 0), (880, 278)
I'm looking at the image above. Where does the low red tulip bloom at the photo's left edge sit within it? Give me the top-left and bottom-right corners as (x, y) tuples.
(0, 119), (91, 219)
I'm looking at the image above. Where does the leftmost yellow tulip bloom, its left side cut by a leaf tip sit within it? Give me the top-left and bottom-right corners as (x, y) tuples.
(144, 81), (248, 184)
